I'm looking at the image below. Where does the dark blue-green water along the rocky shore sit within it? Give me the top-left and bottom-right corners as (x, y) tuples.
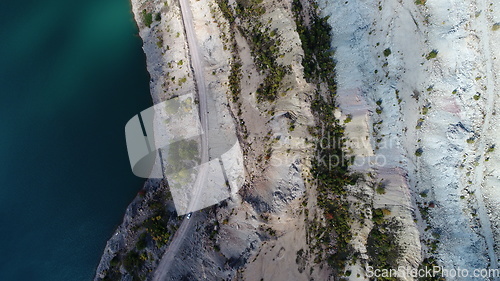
(0, 0), (151, 281)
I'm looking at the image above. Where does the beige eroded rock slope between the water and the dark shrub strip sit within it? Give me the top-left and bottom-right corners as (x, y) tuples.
(97, 1), (321, 280)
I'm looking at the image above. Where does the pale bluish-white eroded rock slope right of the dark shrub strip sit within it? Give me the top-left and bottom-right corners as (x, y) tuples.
(320, 1), (500, 280)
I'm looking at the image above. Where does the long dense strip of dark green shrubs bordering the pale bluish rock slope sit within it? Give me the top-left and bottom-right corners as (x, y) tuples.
(292, 0), (359, 275)
